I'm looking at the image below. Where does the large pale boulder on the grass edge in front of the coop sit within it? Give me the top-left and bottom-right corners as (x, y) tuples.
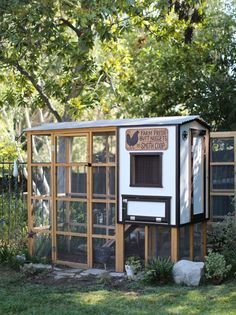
(173, 260), (204, 287)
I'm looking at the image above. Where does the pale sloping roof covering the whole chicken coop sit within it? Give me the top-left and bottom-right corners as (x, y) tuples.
(25, 116), (209, 131)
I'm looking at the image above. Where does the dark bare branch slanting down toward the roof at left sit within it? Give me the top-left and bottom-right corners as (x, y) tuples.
(11, 62), (62, 122)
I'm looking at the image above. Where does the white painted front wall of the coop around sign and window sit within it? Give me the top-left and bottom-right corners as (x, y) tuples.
(119, 125), (176, 224)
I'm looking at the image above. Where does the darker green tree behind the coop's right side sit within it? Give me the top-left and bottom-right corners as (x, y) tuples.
(119, 1), (236, 130)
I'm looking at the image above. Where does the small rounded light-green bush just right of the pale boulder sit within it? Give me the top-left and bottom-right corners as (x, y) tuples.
(205, 250), (231, 284)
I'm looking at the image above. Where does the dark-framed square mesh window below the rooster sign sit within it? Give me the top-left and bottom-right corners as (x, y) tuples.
(130, 153), (162, 187)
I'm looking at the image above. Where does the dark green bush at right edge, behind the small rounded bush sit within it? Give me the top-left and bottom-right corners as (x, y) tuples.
(208, 214), (236, 274)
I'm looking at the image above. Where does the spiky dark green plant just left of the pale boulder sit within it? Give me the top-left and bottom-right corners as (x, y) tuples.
(143, 257), (174, 285)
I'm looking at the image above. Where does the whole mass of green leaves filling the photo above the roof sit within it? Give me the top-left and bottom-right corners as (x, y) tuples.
(0, 0), (232, 128)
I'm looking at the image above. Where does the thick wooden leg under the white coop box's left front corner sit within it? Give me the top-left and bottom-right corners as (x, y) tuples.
(116, 224), (125, 272)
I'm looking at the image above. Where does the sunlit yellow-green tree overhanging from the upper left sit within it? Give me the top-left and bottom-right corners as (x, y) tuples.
(0, 0), (205, 121)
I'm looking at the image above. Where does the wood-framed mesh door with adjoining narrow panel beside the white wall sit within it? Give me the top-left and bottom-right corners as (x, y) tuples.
(56, 132), (116, 269)
